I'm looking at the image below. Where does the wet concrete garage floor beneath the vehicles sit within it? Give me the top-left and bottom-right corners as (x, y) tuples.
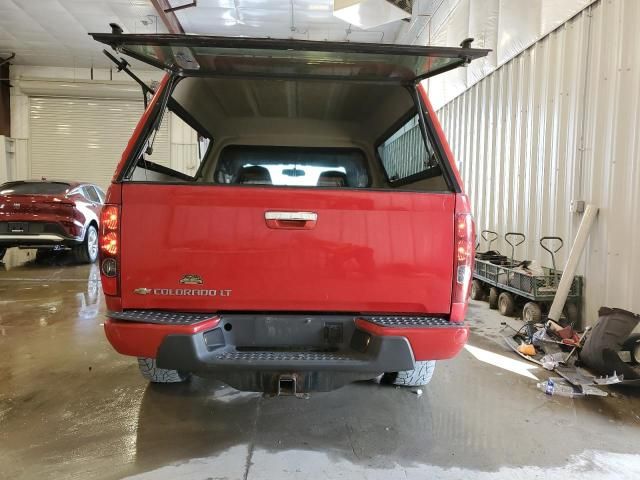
(0, 250), (640, 480)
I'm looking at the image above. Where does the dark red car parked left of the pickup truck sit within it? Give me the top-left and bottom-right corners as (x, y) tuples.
(0, 180), (105, 263)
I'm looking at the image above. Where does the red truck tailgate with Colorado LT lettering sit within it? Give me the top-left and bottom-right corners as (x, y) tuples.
(120, 184), (455, 314)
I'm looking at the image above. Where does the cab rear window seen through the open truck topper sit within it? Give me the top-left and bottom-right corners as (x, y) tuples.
(215, 146), (369, 188)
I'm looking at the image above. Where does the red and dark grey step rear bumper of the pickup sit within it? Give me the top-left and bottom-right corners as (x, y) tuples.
(105, 312), (468, 392)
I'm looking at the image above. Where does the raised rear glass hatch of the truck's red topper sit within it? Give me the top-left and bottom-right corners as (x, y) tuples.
(91, 33), (489, 83)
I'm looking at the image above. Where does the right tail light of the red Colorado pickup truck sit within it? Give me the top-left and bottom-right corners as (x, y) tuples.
(450, 195), (475, 322)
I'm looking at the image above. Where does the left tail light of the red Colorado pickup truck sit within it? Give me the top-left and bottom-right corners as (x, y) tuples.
(99, 204), (120, 295)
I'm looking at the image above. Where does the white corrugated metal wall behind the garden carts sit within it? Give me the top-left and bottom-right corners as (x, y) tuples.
(438, 0), (640, 323)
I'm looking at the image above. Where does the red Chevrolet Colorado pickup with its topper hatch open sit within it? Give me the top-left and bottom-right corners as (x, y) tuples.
(92, 31), (487, 394)
